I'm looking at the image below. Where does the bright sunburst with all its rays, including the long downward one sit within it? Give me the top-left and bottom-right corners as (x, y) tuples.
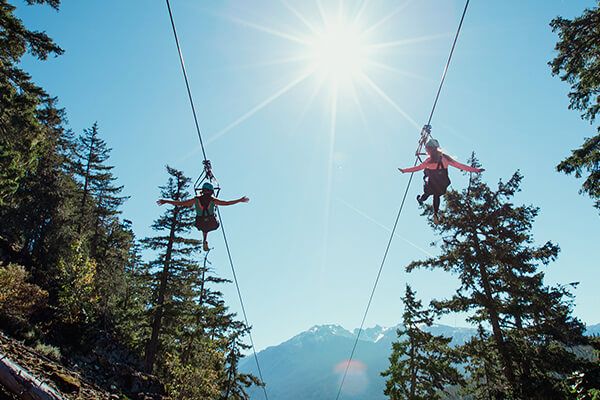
(202, 0), (448, 263)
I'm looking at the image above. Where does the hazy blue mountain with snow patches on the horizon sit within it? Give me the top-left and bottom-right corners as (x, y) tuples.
(240, 325), (475, 400)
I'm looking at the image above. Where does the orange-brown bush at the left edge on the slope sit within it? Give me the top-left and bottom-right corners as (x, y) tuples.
(0, 264), (48, 321)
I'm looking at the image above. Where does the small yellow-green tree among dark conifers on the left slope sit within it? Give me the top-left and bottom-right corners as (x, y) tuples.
(58, 242), (98, 324)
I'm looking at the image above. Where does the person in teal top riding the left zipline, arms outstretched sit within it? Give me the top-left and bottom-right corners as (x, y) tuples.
(156, 182), (250, 251)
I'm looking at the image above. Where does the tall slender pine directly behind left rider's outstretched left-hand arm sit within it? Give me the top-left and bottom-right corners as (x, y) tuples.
(142, 167), (200, 371)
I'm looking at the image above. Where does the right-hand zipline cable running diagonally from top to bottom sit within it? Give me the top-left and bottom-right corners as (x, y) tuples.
(335, 0), (470, 400)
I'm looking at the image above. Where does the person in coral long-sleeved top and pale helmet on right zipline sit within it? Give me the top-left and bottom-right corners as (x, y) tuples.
(399, 139), (484, 224)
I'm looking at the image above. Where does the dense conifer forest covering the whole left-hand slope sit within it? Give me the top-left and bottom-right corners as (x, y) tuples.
(0, 0), (260, 400)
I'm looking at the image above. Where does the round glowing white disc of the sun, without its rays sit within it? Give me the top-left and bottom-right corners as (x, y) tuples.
(308, 22), (367, 83)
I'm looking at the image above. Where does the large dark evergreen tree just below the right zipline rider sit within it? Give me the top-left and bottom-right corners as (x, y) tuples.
(407, 167), (586, 399)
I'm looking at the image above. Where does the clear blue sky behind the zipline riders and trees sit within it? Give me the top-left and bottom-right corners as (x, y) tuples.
(14, 0), (600, 349)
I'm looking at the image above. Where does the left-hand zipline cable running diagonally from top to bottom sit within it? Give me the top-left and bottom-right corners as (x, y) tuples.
(165, 0), (269, 400)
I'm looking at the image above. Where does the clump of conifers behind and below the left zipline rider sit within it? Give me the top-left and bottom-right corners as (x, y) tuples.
(141, 167), (262, 400)
